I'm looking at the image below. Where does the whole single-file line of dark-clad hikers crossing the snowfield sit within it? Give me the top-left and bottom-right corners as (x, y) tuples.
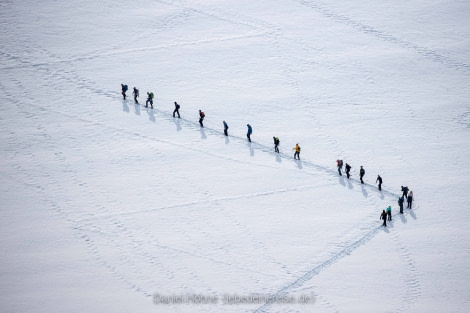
(121, 84), (413, 226)
